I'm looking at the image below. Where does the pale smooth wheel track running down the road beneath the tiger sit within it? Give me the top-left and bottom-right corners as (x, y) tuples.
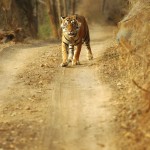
(45, 26), (117, 150)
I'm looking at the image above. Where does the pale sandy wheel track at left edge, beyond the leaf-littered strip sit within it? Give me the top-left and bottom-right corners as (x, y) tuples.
(0, 47), (39, 101)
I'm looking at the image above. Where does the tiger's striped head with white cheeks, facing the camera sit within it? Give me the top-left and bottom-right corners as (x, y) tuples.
(61, 16), (81, 37)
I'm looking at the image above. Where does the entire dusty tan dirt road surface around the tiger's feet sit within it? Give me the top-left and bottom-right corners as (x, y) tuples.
(0, 26), (120, 150)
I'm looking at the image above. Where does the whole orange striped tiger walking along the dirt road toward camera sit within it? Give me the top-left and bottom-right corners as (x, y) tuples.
(60, 14), (93, 67)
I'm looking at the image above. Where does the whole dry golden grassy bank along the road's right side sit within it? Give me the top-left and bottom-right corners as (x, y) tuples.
(100, 0), (150, 150)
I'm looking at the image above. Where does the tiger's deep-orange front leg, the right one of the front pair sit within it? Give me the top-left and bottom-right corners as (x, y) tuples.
(72, 43), (82, 65)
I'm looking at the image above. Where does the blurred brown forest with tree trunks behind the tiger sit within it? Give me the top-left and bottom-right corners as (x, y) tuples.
(0, 0), (128, 38)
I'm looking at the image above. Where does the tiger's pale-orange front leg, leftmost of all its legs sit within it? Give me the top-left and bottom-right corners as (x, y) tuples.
(60, 42), (68, 67)
